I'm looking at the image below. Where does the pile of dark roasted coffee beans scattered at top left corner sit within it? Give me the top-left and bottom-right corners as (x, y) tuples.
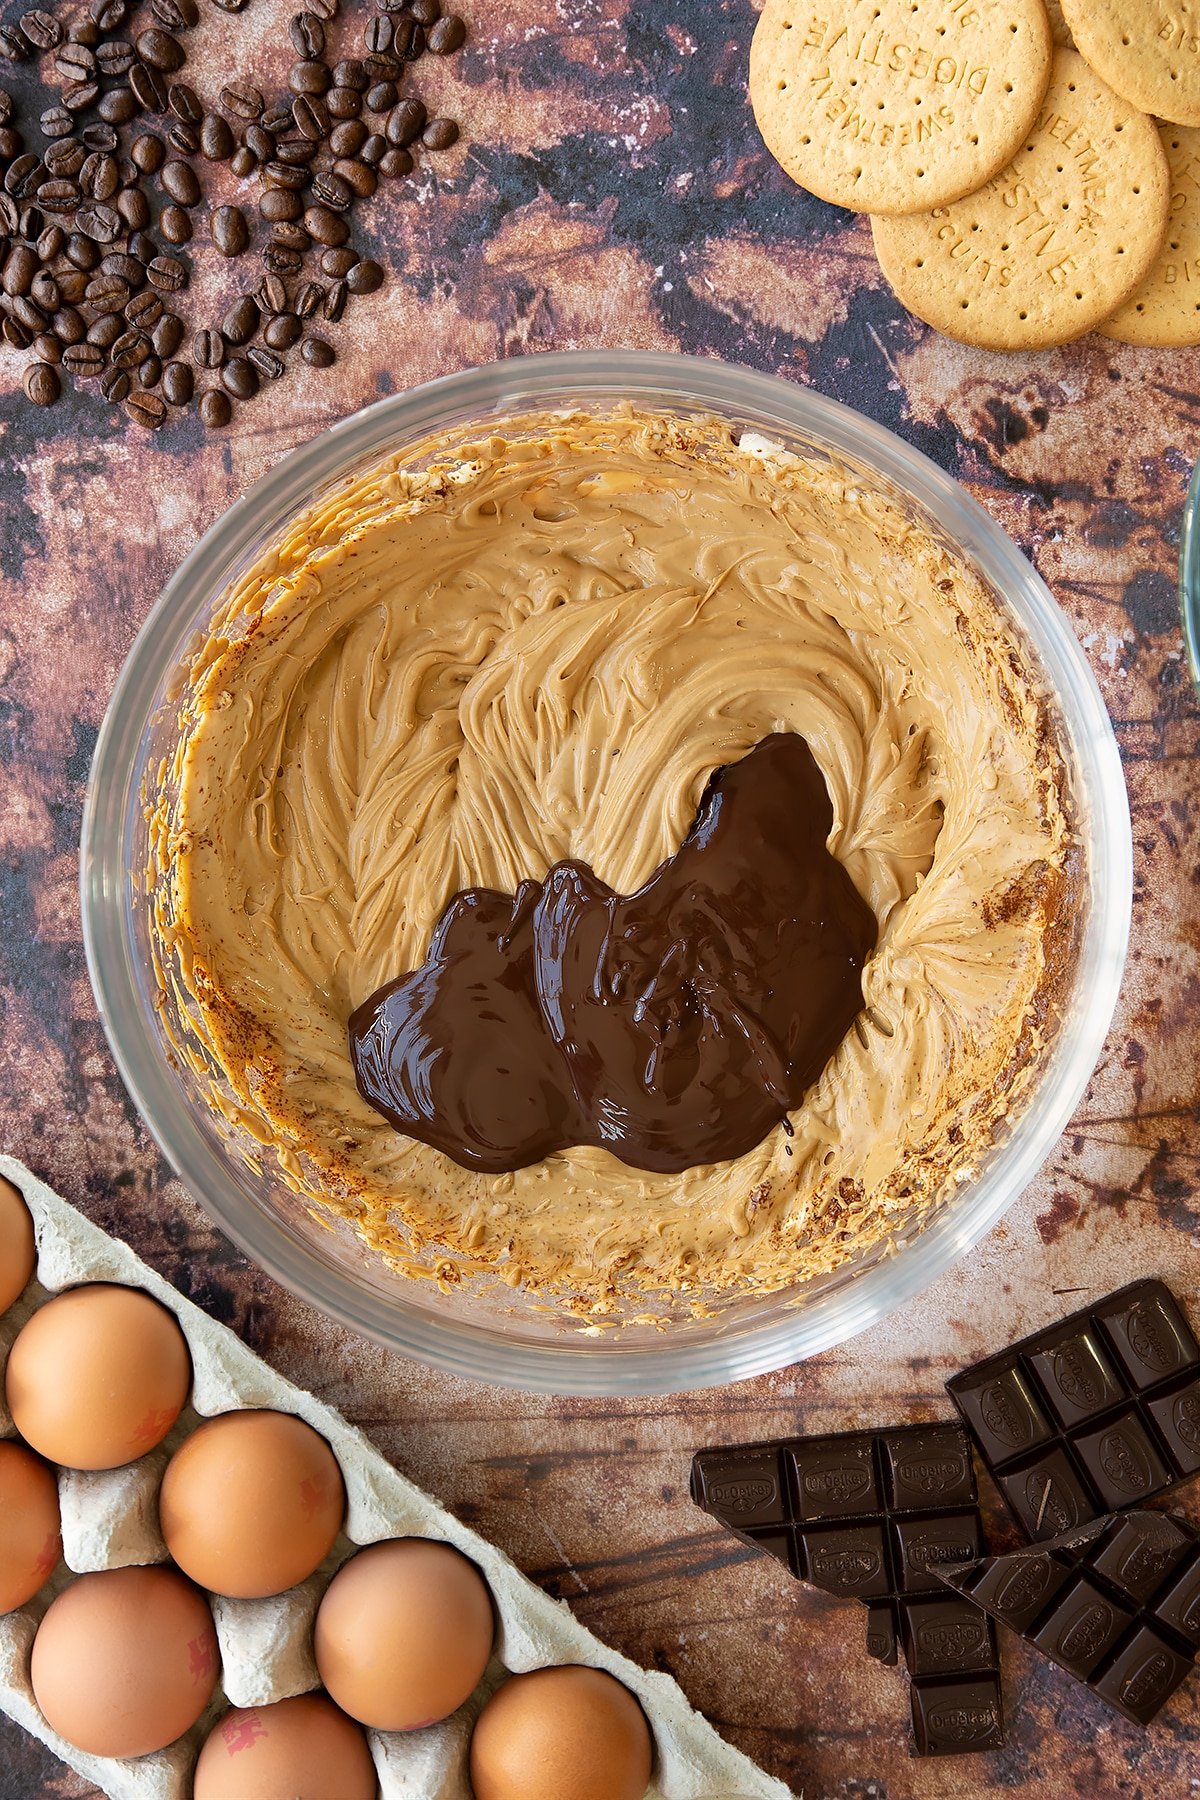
(0, 0), (466, 430)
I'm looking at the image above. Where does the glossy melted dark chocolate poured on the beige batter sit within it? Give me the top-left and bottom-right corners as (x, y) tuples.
(349, 733), (876, 1172)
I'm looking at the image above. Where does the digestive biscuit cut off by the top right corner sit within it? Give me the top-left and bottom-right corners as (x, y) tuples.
(1061, 0), (1200, 124)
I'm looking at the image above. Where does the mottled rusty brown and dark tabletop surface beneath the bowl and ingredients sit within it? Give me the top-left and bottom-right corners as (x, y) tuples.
(0, 0), (1200, 1800)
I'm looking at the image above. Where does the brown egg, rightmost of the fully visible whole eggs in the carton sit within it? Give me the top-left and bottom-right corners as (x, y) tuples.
(313, 1537), (495, 1732)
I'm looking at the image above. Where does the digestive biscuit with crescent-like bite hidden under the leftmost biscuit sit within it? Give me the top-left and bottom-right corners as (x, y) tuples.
(873, 50), (1171, 351)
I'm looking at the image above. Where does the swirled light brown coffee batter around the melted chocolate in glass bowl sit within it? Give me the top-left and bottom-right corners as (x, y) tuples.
(151, 412), (1074, 1318)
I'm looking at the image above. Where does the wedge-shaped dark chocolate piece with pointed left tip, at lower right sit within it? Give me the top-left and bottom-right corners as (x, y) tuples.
(943, 1510), (1200, 1724)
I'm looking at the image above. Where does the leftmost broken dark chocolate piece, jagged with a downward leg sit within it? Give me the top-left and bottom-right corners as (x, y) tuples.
(691, 1426), (1004, 1755)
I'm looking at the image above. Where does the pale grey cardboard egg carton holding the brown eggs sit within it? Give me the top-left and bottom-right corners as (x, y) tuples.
(0, 1156), (790, 1800)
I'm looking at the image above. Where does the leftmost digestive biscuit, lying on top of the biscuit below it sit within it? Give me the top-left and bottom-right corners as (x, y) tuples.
(750, 0), (1052, 216)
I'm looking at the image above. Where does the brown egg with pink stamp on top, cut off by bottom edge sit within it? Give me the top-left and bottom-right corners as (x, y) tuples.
(193, 1694), (378, 1800)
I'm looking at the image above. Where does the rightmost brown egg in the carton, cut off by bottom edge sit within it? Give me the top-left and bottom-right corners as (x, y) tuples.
(471, 1663), (655, 1800)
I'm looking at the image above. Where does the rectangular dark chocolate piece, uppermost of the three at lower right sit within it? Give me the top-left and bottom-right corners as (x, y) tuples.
(946, 1282), (1200, 1539)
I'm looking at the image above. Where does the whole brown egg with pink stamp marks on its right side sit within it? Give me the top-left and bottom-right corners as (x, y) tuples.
(31, 1566), (221, 1757)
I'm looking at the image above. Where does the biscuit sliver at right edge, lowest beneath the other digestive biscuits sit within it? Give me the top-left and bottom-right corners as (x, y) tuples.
(1099, 124), (1200, 349)
